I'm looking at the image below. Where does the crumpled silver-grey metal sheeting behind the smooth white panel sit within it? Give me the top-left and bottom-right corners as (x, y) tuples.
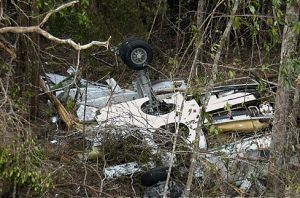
(45, 73), (187, 121)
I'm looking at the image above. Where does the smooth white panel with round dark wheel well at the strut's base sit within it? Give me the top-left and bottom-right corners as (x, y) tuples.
(96, 93), (207, 149)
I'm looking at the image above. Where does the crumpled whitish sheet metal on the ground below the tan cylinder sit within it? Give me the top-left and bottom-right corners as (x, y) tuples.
(202, 135), (271, 191)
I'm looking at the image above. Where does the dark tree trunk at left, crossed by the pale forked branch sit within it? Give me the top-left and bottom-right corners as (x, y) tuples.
(15, 0), (40, 118)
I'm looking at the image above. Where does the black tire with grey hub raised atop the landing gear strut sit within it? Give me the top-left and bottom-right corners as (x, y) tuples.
(119, 37), (153, 70)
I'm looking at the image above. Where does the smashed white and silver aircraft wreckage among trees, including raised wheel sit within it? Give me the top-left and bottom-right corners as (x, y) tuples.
(46, 39), (275, 196)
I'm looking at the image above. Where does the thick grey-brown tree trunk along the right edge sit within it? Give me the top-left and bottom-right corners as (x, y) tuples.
(270, 3), (300, 196)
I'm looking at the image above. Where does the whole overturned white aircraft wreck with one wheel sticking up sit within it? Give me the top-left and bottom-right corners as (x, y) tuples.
(45, 38), (276, 197)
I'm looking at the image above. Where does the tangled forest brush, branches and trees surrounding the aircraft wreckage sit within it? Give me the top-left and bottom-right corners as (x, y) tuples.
(0, 0), (300, 197)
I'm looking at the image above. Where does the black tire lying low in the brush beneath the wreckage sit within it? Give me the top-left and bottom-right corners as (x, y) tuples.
(141, 167), (169, 186)
